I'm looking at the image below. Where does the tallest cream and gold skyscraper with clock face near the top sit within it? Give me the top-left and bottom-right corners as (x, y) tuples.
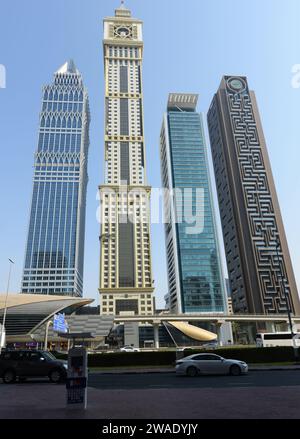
(99, 3), (153, 315)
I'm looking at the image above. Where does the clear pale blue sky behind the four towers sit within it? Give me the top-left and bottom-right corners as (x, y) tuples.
(0, 0), (300, 306)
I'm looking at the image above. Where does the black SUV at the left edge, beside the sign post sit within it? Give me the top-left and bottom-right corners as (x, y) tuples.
(0, 349), (67, 384)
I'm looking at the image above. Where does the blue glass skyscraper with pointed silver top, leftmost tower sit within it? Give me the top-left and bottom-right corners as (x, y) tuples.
(22, 61), (90, 296)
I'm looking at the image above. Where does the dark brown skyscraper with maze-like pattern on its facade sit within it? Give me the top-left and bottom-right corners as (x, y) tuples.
(208, 76), (300, 314)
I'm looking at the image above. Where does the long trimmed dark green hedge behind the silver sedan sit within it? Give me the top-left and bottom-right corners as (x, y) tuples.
(55, 347), (295, 367)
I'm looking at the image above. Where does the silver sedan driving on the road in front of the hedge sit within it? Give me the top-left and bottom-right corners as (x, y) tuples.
(176, 354), (248, 377)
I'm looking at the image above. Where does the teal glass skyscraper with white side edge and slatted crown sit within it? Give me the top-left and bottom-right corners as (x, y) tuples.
(160, 93), (226, 313)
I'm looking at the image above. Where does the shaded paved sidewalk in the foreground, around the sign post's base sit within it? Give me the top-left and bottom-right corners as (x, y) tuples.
(0, 382), (299, 420)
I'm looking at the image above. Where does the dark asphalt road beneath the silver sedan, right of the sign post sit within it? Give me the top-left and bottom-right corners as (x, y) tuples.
(88, 370), (300, 390)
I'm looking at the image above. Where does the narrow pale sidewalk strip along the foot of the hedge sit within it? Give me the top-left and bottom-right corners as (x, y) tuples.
(90, 364), (300, 375)
